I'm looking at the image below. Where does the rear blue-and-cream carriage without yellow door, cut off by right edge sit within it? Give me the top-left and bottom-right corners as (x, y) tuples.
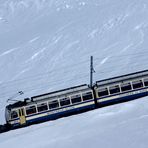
(95, 70), (148, 106)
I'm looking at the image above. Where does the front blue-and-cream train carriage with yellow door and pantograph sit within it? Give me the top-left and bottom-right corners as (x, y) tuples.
(6, 85), (95, 127)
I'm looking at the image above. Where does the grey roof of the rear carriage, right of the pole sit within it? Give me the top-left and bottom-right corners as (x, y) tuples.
(96, 70), (148, 86)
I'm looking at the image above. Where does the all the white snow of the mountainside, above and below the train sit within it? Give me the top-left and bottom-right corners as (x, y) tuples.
(0, 0), (148, 148)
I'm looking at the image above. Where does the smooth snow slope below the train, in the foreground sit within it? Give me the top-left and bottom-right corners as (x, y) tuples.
(0, 97), (148, 148)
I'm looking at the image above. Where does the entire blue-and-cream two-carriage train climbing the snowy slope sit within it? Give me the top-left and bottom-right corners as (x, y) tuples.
(0, 70), (148, 132)
